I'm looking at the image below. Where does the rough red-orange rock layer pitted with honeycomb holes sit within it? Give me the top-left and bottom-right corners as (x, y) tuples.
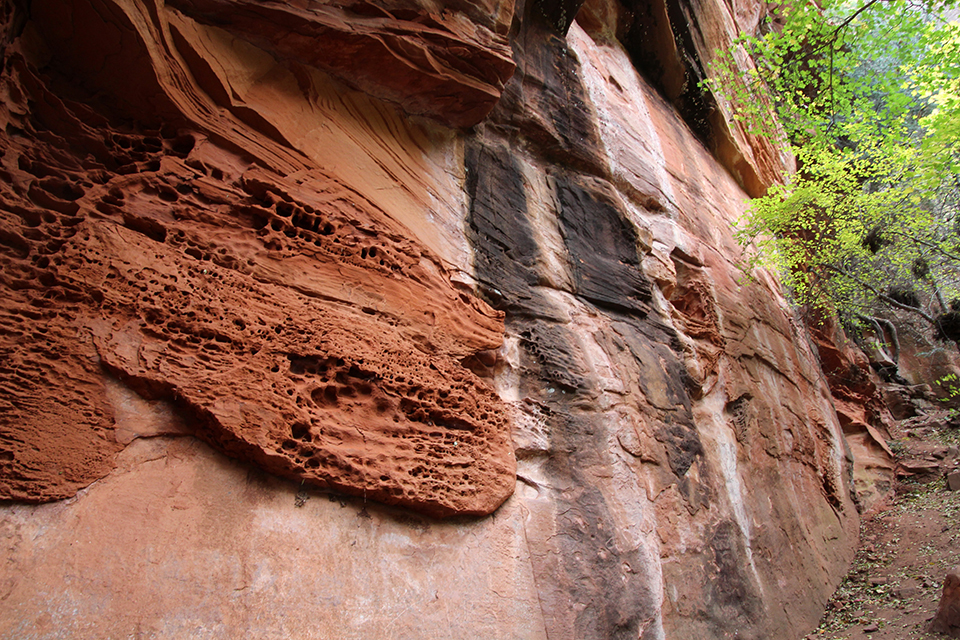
(2, 0), (514, 516)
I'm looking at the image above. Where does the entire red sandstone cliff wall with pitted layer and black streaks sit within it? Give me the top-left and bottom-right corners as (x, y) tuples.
(0, 0), (858, 640)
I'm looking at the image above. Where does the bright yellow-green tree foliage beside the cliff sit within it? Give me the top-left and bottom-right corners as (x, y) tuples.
(708, 0), (960, 323)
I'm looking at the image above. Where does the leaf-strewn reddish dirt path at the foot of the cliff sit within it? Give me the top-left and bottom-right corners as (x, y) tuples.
(806, 413), (960, 640)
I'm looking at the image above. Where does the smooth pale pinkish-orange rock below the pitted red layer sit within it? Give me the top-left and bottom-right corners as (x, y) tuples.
(0, 438), (546, 640)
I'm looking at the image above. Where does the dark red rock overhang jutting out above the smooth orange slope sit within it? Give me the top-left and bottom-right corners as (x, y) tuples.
(169, 0), (514, 127)
